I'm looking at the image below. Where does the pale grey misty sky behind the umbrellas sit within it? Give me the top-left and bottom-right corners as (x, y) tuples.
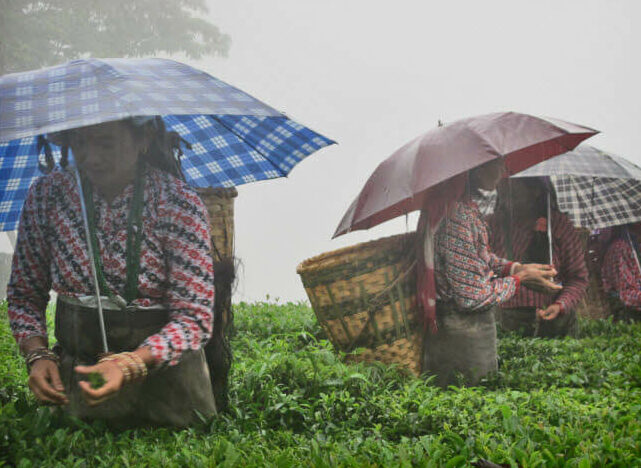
(190, 0), (641, 301)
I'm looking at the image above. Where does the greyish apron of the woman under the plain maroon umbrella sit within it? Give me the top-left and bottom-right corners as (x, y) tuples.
(423, 302), (498, 387)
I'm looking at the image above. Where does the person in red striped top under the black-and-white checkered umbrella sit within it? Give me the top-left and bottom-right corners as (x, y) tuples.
(488, 178), (588, 337)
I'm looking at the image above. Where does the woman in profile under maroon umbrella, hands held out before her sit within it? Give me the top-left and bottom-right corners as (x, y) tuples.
(419, 159), (559, 386)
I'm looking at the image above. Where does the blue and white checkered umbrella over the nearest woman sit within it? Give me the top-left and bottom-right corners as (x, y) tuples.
(0, 59), (334, 231)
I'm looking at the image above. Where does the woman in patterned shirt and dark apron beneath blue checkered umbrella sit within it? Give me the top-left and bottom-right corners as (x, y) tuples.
(8, 117), (216, 426)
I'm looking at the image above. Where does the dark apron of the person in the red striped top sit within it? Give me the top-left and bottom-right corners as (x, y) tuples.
(496, 307), (579, 338)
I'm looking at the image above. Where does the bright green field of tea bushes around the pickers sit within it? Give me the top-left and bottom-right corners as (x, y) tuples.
(0, 303), (641, 468)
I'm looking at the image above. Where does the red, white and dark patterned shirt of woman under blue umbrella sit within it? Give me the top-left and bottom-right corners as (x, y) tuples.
(7, 167), (214, 365)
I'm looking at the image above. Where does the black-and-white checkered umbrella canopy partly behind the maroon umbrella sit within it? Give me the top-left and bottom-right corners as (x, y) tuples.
(512, 145), (641, 229)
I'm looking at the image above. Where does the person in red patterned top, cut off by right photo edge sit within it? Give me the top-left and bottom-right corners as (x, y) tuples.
(601, 223), (641, 321)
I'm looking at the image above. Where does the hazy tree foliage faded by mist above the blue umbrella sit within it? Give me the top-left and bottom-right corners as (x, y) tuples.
(0, 0), (230, 75)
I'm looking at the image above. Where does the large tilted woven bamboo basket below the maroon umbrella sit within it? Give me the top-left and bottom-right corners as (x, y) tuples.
(296, 233), (422, 375)
